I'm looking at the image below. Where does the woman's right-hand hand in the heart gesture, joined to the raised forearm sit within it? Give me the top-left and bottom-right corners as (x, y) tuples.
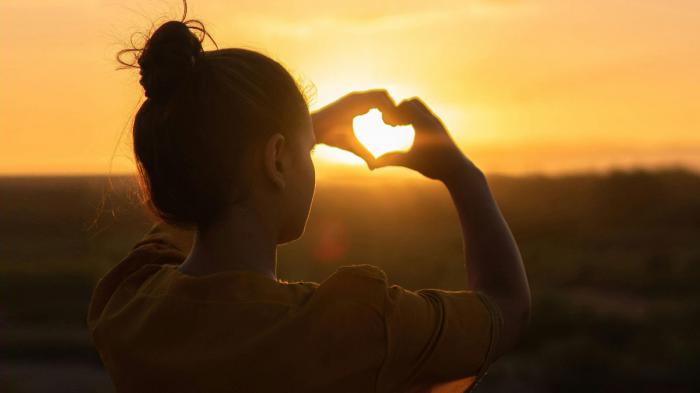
(370, 98), (475, 182)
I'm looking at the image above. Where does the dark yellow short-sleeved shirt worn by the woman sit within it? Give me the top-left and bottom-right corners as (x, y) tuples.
(88, 222), (502, 393)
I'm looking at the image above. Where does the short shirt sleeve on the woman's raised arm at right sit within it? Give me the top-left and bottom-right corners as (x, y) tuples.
(377, 274), (502, 393)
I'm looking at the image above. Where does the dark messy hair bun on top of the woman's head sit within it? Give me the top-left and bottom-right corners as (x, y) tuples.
(138, 21), (202, 99)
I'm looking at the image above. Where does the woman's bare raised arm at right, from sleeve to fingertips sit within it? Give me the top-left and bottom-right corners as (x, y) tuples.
(372, 99), (530, 356)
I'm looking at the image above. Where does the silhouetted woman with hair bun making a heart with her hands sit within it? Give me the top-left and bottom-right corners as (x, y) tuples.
(88, 6), (530, 392)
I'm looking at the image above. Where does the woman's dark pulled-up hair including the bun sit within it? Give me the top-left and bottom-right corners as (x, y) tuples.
(120, 15), (308, 228)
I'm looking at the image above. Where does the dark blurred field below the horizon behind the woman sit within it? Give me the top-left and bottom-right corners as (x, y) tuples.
(0, 170), (700, 393)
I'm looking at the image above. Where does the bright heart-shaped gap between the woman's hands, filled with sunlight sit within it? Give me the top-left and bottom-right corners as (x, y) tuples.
(352, 109), (416, 158)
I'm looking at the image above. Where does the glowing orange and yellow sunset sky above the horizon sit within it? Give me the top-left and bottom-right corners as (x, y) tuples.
(0, 0), (700, 174)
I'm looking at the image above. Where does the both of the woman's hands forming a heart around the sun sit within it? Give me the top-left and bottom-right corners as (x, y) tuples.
(311, 90), (464, 179)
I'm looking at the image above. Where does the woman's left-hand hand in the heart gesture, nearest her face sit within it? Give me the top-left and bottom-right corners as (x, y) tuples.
(311, 90), (397, 169)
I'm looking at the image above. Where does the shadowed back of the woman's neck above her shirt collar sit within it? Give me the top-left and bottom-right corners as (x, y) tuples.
(178, 206), (277, 281)
